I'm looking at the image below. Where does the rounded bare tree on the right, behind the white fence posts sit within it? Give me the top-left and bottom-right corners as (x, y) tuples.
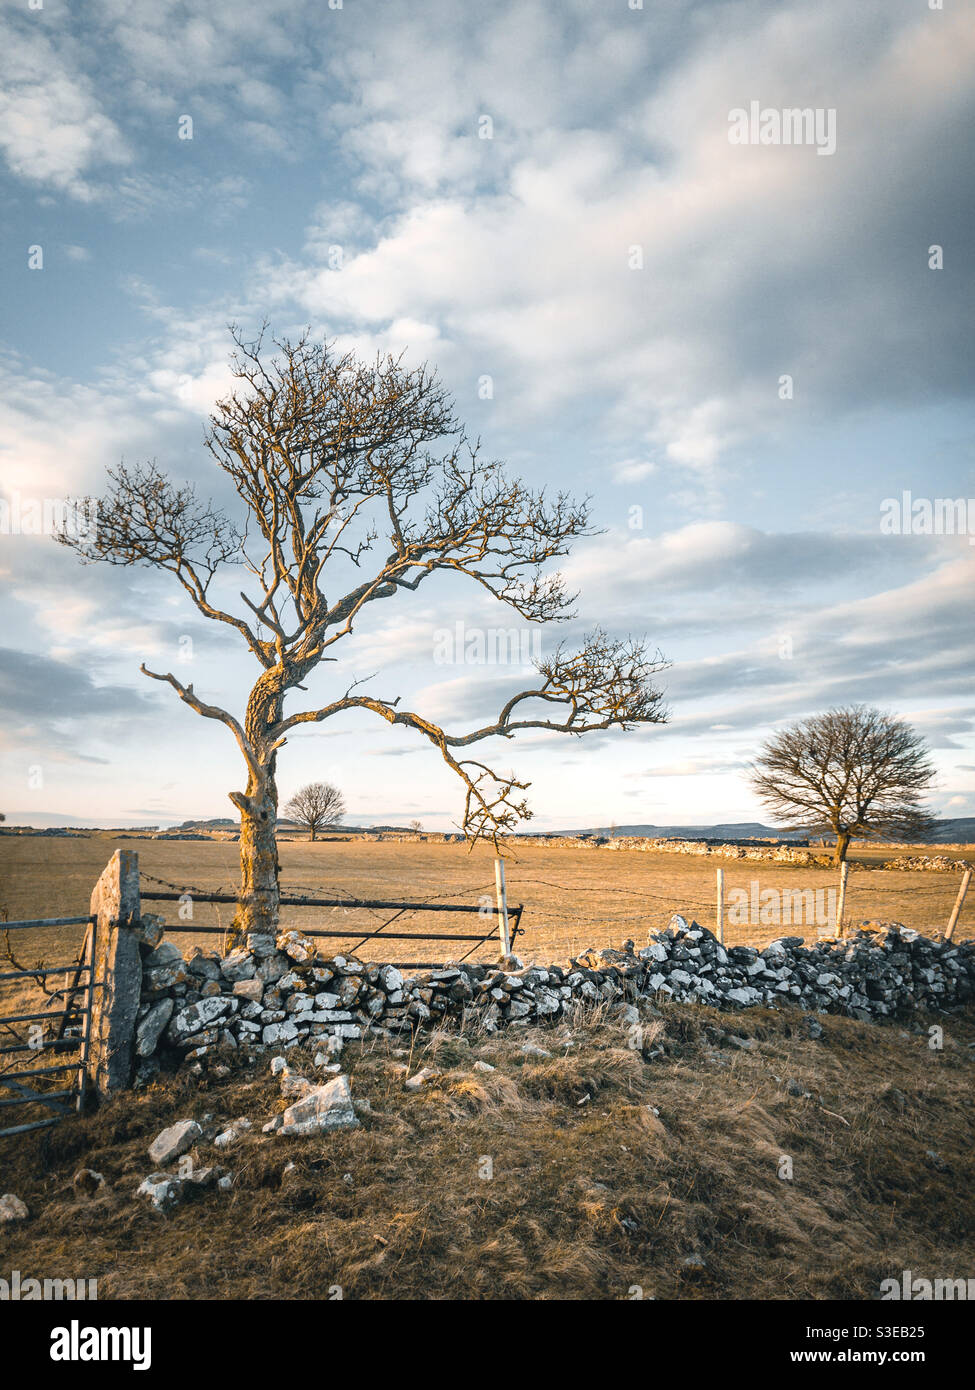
(751, 705), (935, 863)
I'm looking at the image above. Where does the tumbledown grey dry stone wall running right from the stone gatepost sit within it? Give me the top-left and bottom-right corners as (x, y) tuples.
(135, 916), (975, 1083)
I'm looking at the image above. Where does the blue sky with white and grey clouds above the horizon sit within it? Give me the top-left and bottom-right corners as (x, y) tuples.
(0, 0), (975, 830)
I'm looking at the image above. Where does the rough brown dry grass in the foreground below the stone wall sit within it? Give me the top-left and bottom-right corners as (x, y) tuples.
(0, 1005), (975, 1300)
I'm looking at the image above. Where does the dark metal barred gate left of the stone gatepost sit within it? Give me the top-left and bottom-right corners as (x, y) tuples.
(0, 917), (98, 1137)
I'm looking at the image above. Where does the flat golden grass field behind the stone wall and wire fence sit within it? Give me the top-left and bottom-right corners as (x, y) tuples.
(0, 833), (975, 963)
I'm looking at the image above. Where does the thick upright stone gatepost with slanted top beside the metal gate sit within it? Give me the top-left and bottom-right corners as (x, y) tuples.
(88, 849), (142, 1095)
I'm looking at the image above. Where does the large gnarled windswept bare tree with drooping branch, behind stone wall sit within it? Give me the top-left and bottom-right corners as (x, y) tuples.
(58, 329), (666, 933)
